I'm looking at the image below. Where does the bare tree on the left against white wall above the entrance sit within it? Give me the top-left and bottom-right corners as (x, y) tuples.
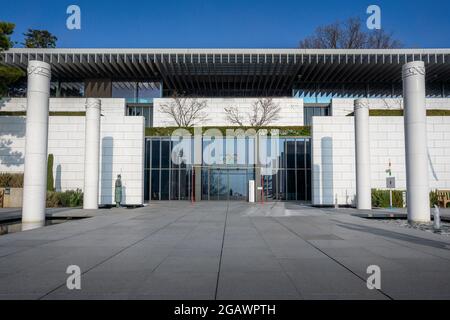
(160, 93), (208, 127)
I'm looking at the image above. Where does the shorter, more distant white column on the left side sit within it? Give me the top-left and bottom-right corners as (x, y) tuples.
(83, 98), (101, 209)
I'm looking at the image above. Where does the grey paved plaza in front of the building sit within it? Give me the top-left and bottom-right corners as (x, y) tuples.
(0, 201), (450, 299)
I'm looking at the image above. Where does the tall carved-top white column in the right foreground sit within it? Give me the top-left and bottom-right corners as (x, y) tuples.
(402, 61), (430, 222)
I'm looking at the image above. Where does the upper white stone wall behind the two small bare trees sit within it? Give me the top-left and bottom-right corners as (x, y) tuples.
(153, 98), (303, 127)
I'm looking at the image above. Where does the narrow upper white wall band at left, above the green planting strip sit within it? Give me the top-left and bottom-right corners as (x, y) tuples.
(0, 98), (125, 116)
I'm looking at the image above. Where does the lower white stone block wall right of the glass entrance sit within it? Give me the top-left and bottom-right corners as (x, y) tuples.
(312, 117), (450, 205)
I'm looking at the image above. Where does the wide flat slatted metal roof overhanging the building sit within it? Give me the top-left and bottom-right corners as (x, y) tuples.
(0, 49), (450, 95)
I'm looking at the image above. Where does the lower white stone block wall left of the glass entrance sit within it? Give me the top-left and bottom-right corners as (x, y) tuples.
(0, 115), (144, 204)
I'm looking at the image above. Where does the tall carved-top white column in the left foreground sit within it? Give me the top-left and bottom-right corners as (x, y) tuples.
(22, 60), (51, 225)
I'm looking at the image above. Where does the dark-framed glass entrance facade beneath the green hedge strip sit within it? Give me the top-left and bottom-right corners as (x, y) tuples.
(144, 137), (311, 201)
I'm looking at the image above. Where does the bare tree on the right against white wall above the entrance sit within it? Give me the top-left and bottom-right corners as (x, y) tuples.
(225, 98), (280, 127)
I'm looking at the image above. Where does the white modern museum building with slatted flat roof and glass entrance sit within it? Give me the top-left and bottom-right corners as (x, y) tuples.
(0, 49), (450, 206)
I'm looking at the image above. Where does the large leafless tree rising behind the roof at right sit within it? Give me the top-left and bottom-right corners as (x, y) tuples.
(300, 17), (402, 49)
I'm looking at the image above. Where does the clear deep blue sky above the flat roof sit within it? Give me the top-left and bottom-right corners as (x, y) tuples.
(0, 0), (450, 48)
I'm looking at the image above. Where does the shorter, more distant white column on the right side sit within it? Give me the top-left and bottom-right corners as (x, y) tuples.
(354, 99), (372, 210)
